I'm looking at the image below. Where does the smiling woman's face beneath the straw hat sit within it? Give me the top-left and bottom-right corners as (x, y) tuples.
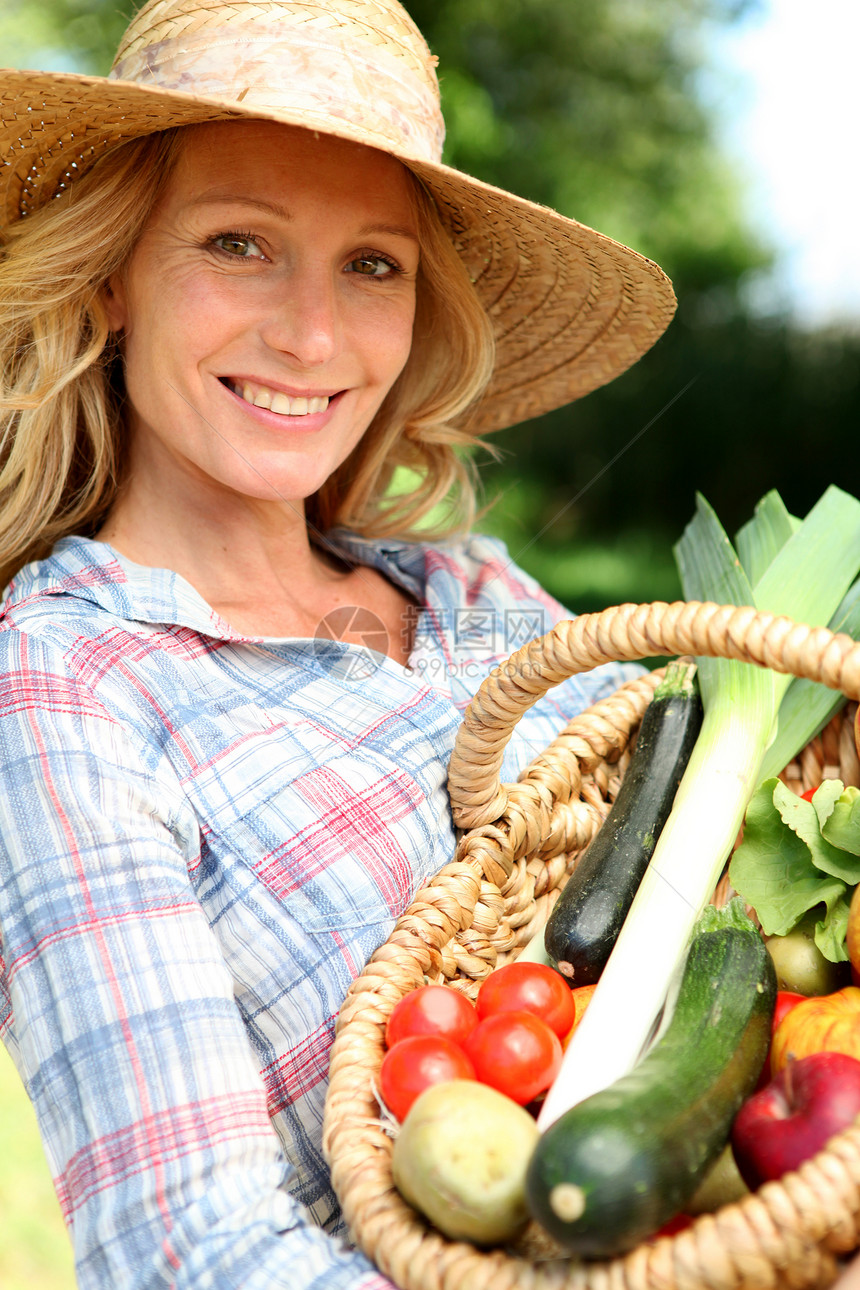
(106, 121), (419, 513)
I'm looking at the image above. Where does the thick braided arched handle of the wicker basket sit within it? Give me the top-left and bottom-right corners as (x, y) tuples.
(447, 601), (860, 828)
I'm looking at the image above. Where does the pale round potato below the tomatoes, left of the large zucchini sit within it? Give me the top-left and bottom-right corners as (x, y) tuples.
(392, 1080), (538, 1245)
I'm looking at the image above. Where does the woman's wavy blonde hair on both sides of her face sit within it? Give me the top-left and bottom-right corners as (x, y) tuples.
(0, 129), (494, 586)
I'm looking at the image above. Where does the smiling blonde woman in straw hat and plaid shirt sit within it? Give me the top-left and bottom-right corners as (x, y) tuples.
(0, 0), (673, 1290)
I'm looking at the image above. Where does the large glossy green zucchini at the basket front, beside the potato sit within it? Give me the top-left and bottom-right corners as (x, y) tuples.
(526, 902), (776, 1259)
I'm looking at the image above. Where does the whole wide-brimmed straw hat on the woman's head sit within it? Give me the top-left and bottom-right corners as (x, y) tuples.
(0, 0), (674, 431)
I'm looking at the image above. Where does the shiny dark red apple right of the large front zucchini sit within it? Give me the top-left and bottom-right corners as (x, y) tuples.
(731, 1053), (860, 1189)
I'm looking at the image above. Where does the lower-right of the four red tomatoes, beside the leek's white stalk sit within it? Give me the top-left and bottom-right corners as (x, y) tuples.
(466, 1013), (562, 1107)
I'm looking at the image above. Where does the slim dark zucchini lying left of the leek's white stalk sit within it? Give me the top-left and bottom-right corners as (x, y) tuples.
(544, 659), (703, 986)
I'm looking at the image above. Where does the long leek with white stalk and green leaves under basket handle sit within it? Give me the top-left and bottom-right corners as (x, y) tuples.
(538, 488), (860, 1131)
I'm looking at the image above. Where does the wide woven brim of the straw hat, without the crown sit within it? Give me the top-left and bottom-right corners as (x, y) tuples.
(0, 70), (676, 433)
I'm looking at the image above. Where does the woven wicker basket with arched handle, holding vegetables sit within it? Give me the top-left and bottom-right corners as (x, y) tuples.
(324, 602), (860, 1290)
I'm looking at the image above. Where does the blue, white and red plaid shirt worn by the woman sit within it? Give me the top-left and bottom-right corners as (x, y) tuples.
(0, 534), (639, 1290)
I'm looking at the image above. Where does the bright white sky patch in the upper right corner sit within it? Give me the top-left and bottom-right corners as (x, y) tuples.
(714, 0), (860, 326)
